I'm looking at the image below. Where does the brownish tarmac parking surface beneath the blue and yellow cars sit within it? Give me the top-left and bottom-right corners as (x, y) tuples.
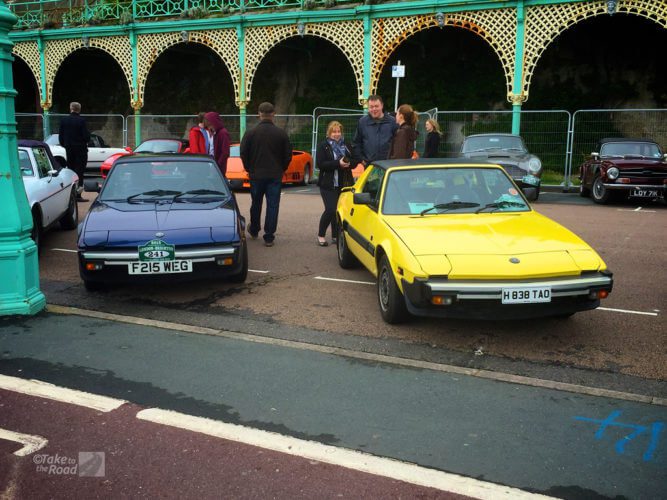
(35, 186), (667, 386)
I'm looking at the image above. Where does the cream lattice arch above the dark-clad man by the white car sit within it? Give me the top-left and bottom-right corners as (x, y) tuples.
(43, 36), (132, 109)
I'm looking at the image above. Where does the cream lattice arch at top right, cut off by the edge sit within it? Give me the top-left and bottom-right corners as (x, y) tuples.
(522, 0), (667, 100)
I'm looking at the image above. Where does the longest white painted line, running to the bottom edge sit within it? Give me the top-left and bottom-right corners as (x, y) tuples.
(137, 408), (551, 499)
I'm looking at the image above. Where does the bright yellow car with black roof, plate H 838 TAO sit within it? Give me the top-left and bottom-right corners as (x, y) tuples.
(337, 159), (613, 323)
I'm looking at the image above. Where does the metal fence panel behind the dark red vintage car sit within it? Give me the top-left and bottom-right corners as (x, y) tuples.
(569, 109), (667, 182)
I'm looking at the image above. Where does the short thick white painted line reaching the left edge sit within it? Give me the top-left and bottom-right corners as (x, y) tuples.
(0, 375), (127, 412)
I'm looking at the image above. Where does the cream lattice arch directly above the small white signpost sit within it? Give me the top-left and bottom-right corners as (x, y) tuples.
(370, 8), (516, 102)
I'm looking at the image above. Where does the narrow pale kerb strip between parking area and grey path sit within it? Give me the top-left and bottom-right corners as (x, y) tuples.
(47, 304), (667, 406)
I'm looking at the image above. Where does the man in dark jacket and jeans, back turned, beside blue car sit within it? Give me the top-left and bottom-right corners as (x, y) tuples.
(241, 102), (292, 247)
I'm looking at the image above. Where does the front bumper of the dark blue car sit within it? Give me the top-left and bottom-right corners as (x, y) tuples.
(79, 243), (245, 284)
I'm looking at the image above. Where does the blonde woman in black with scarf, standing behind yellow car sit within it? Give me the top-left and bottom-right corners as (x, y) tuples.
(315, 121), (354, 247)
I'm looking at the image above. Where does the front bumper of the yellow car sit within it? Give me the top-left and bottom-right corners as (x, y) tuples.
(403, 271), (614, 320)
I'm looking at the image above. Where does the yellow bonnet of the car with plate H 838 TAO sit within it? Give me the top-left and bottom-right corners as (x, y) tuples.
(387, 212), (604, 279)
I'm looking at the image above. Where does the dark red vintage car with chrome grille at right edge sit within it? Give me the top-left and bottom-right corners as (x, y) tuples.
(579, 138), (667, 203)
